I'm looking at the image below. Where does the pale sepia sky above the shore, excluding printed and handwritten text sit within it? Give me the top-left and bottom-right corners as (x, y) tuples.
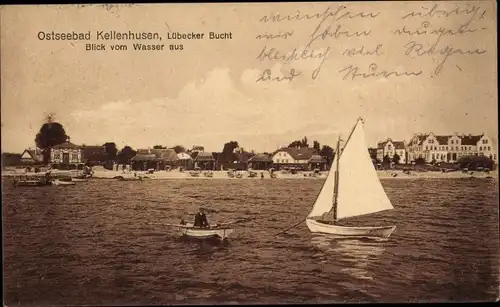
(1, 2), (498, 152)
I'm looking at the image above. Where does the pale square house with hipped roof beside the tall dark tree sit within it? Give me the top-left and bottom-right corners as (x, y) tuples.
(50, 141), (84, 170)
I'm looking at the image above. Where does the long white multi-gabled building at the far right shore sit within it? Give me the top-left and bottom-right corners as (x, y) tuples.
(407, 132), (498, 163)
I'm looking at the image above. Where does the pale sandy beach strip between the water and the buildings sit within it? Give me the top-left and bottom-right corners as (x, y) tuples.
(2, 169), (498, 181)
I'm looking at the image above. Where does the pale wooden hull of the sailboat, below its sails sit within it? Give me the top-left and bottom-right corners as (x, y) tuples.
(306, 219), (396, 238)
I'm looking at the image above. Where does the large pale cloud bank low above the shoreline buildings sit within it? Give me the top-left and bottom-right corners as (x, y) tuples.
(67, 65), (336, 150)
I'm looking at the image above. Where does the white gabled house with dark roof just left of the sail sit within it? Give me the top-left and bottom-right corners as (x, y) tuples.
(272, 147), (318, 170)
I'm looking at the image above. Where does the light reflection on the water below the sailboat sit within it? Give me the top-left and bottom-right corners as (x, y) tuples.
(311, 234), (385, 279)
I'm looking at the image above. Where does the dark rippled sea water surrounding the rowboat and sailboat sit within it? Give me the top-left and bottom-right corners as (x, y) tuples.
(3, 179), (499, 306)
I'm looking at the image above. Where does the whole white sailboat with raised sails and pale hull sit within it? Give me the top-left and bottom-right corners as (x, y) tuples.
(306, 118), (396, 238)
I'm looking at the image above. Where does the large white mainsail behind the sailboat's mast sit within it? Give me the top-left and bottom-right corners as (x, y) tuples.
(336, 120), (394, 219)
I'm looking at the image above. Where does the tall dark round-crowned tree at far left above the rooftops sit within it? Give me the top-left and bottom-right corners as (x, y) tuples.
(35, 114), (69, 163)
